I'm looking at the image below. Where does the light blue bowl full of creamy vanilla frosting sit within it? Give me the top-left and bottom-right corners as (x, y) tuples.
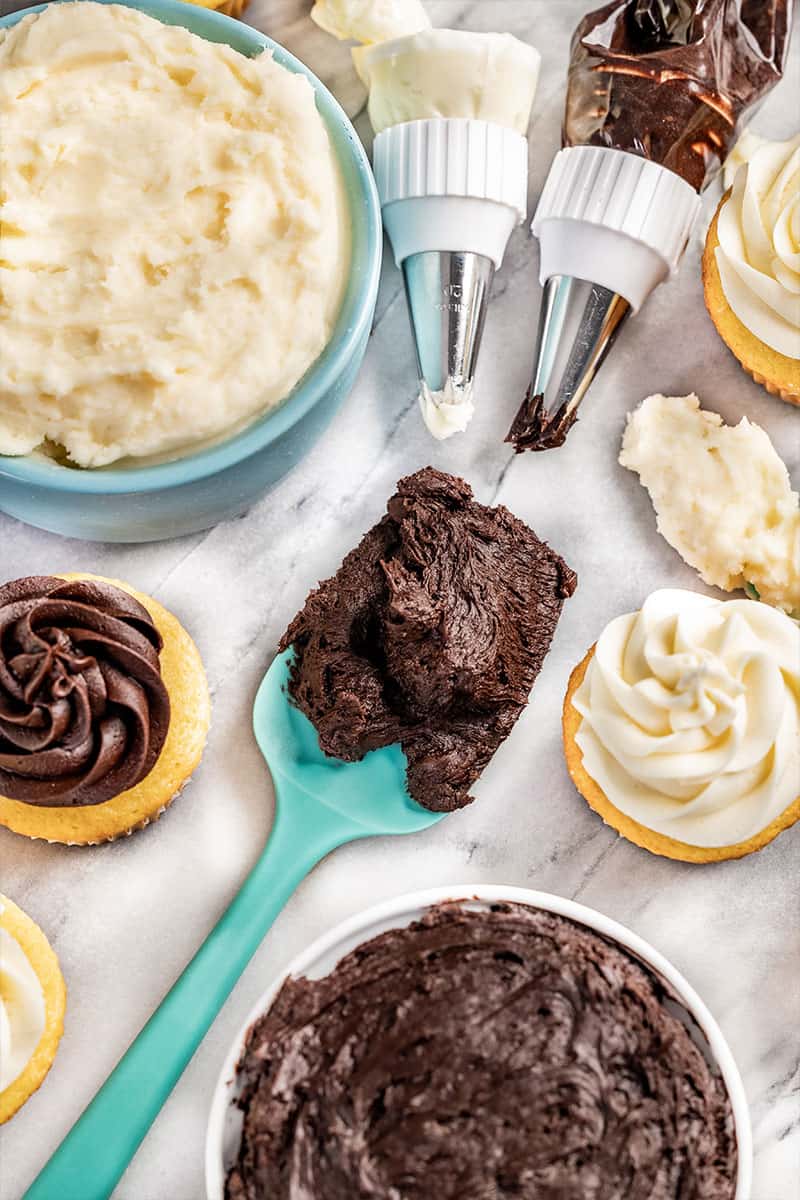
(0, 0), (380, 540)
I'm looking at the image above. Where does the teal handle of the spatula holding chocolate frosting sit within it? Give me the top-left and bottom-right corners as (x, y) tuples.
(23, 779), (368, 1200)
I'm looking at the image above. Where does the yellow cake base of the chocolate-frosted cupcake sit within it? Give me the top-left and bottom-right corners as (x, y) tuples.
(0, 574), (211, 846)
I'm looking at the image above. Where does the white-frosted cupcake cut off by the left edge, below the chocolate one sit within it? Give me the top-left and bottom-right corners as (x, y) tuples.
(0, 895), (67, 1124)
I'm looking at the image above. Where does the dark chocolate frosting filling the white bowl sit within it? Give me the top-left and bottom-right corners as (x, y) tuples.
(225, 904), (736, 1200)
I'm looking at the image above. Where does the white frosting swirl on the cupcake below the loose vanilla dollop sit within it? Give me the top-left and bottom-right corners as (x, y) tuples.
(573, 590), (800, 847)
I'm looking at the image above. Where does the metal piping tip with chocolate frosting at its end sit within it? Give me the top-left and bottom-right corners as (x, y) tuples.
(506, 275), (631, 454)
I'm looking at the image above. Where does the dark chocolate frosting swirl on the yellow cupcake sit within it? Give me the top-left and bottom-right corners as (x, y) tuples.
(0, 575), (169, 808)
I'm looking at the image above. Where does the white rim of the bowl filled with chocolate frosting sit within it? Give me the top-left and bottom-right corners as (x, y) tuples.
(205, 883), (753, 1200)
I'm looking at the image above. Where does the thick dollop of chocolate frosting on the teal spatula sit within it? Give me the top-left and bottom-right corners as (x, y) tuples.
(281, 467), (576, 811)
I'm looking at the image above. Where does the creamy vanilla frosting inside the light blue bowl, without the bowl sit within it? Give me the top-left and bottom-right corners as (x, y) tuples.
(0, 2), (348, 467)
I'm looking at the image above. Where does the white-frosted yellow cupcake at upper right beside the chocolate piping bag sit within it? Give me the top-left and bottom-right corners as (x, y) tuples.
(703, 133), (800, 404)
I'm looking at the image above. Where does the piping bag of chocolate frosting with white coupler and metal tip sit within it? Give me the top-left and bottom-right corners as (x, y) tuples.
(506, 0), (792, 452)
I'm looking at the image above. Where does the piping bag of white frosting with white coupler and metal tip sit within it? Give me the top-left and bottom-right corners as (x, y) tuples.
(353, 29), (540, 439)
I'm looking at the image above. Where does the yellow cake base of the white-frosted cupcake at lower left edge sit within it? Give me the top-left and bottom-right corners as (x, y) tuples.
(0, 896), (67, 1124)
